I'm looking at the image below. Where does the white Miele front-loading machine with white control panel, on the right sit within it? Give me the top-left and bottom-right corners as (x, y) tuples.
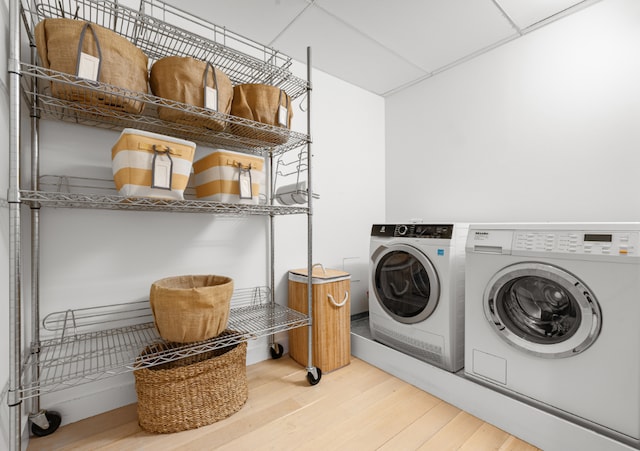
(464, 223), (640, 447)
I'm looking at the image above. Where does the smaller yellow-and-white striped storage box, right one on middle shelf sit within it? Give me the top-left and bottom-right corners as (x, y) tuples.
(193, 150), (265, 205)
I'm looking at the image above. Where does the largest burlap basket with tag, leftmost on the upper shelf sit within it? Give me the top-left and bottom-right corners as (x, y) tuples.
(35, 19), (148, 114)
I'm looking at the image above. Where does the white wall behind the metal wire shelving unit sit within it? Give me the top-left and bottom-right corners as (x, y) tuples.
(0, 14), (384, 430)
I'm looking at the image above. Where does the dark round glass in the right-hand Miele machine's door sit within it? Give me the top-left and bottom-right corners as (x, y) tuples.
(496, 276), (581, 344)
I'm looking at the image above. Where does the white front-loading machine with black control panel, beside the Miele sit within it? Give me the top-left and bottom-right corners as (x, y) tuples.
(369, 224), (468, 372)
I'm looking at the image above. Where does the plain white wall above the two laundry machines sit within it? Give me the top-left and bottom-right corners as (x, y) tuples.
(386, 0), (640, 222)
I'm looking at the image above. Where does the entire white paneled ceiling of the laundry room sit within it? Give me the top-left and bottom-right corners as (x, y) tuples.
(168, 0), (604, 96)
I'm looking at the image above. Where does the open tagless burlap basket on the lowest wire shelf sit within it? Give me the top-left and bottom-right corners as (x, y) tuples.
(150, 275), (233, 343)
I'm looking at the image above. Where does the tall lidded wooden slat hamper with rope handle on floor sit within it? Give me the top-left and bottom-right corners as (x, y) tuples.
(289, 266), (351, 373)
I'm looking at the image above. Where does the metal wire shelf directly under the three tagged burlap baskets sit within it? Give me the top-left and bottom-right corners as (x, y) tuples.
(21, 63), (309, 155)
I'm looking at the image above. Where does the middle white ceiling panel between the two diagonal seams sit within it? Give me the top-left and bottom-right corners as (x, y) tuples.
(315, 0), (522, 71)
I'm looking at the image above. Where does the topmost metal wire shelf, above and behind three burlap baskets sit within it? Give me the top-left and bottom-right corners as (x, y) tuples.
(22, 0), (308, 99)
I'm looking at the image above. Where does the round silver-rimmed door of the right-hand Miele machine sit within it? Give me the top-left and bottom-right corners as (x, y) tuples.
(484, 263), (602, 358)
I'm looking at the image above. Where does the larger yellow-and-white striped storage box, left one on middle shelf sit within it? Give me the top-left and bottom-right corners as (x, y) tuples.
(111, 128), (196, 200)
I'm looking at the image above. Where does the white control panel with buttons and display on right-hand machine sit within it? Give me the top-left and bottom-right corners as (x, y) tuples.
(513, 231), (640, 256)
